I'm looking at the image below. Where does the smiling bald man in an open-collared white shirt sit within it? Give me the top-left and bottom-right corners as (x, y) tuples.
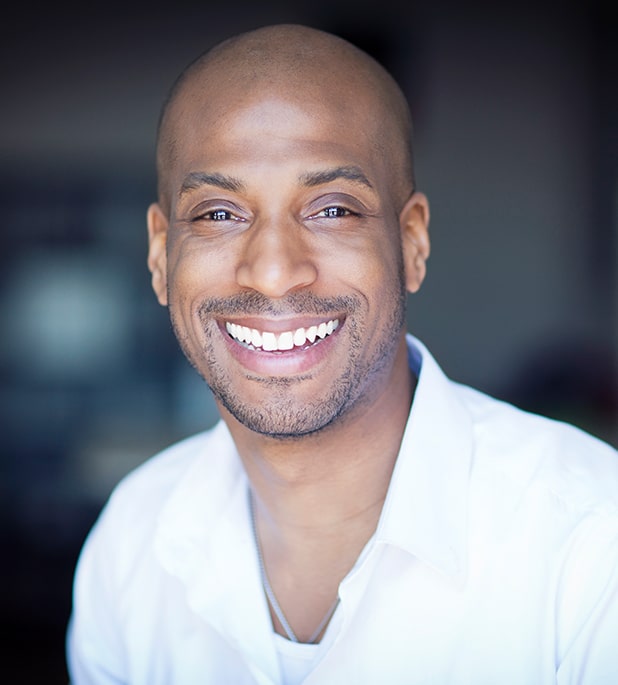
(68, 25), (618, 685)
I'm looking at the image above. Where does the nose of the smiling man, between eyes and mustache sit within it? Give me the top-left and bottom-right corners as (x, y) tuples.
(236, 218), (318, 298)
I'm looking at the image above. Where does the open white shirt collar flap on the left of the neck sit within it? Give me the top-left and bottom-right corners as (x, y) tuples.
(154, 421), (279, 679)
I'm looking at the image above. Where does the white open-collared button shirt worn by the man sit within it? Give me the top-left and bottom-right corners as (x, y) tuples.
(68, 338), (618, 685)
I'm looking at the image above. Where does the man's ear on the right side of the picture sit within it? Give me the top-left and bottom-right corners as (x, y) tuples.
(399, 193), (430, 293)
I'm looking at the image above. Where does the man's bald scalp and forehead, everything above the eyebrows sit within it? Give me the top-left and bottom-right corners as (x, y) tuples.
(157, 29), (413, 208)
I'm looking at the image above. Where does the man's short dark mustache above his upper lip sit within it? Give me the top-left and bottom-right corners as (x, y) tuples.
(198, 292), (360, 320)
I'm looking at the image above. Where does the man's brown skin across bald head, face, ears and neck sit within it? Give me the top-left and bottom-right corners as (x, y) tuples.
(148, 26), (429, 640)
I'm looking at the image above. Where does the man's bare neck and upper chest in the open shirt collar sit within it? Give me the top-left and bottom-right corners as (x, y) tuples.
(222, 338), (414, 641)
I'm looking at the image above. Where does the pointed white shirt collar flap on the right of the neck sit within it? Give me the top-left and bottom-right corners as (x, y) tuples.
(376, 335), (473, 582)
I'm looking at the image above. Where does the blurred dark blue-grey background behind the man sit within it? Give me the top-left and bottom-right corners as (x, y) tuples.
(0, 0), (618, 685)
